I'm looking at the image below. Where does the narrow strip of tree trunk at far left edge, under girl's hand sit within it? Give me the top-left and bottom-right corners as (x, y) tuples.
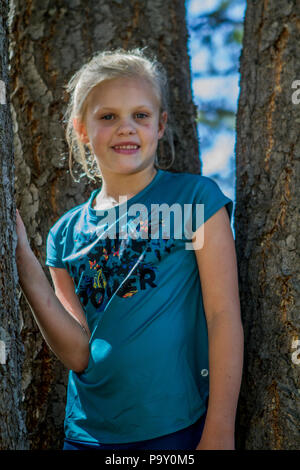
(0, 0), (27, 450)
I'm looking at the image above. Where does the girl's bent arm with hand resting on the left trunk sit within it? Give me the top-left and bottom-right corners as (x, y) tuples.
(16, 211), (90, 372)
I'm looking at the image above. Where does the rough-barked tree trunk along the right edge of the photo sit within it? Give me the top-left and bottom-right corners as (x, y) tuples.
(235, 0), (300, 449)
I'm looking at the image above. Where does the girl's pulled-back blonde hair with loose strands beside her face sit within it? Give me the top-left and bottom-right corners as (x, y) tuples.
(65, 47), (175, 180)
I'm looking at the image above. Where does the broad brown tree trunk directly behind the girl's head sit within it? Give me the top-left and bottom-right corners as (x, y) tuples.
(11, 0), (200, 449)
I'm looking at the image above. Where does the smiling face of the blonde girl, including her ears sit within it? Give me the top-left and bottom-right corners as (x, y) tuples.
(73, 77), (167, 174)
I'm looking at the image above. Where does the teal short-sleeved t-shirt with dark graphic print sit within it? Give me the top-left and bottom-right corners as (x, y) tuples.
(46, 170), (233, 444)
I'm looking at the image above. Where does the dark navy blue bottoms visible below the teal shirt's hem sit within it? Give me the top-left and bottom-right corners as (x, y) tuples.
(63, 412), (206, 450)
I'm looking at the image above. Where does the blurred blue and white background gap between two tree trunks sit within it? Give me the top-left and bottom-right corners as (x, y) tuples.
(186, 0), (246, 200)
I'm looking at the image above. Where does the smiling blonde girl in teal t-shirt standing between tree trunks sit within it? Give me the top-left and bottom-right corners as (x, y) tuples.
(16, 49), (243, 450)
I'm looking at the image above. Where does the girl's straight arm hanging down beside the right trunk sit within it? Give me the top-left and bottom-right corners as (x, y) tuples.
(195, 207), (243, 450)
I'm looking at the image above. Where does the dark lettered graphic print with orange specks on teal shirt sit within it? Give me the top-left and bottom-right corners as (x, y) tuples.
(66, 216), (175, 311)
